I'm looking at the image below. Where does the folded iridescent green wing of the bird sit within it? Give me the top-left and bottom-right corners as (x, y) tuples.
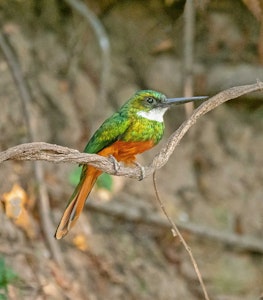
(84, 113), (130, 153)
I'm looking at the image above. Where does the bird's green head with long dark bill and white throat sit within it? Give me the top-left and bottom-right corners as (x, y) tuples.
(123, 90), (207, 122)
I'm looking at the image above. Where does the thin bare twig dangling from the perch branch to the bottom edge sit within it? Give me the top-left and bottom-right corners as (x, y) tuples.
(153, 171), (209, 300)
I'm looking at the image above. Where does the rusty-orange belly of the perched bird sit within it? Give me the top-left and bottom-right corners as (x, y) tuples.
(98, 141), (154, 164)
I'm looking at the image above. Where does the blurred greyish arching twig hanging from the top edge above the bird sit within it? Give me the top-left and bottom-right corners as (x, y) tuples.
(64, 0), (110, 100)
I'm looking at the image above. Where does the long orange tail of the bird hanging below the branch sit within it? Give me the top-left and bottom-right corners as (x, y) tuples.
(55, 166), (102, 240)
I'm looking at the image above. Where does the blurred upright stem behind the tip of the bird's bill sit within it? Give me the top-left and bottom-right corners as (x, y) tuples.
(183, 0), (195, 117)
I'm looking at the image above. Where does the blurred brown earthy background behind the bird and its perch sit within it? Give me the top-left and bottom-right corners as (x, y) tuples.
(0, 0), (263, 300)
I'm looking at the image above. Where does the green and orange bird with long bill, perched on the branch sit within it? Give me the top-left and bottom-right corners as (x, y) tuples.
(55, 90), (207, 239)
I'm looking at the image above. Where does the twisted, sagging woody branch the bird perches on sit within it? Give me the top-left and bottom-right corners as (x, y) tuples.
(0, 81), (263, 180)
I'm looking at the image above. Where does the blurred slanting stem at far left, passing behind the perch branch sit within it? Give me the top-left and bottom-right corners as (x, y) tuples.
(0, 32), (64, 268)
